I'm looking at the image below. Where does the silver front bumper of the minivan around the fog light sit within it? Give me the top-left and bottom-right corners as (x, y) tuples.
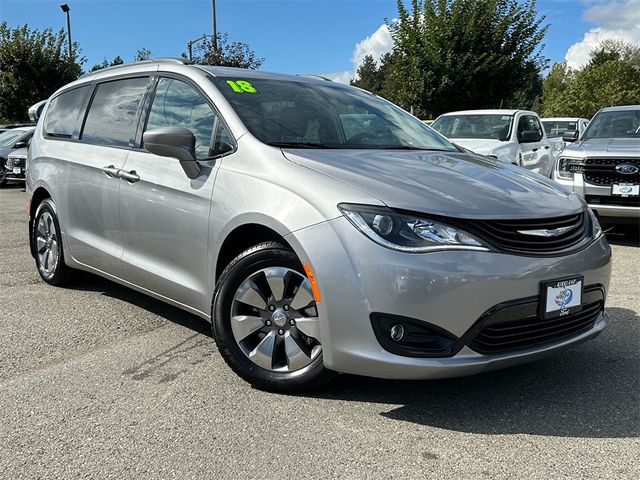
(287, 218), (611, 379)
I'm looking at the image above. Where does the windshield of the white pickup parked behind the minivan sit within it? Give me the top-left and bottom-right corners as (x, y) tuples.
(431, 114), (513, 142)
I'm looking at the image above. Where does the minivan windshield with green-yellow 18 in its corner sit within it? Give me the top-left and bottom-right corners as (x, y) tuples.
(213, 77), (458, 151)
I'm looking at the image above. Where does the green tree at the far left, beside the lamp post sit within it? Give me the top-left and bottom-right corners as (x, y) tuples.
(0, 22), (84, 121)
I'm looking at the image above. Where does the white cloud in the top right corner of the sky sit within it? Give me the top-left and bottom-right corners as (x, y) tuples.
(565, 0), (640, 68)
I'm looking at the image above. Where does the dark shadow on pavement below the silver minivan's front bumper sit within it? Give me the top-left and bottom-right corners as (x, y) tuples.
(310, 308), (640, 438)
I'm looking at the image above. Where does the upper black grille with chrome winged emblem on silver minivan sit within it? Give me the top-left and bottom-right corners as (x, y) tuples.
(466, 212), (591, 255)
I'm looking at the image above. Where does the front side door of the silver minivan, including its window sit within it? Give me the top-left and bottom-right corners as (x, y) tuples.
(119, 77), (234, 313)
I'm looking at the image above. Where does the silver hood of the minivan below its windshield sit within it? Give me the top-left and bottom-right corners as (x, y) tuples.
(283, 149), (584, 219)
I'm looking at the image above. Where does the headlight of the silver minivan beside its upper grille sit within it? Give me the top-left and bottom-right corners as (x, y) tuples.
(338, 204), (490, 253)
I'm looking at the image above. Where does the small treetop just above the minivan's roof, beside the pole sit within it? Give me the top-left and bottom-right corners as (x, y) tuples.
(189, 33), (264, 70)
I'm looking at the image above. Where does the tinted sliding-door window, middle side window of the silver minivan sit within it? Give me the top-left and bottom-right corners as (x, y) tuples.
(81, 78), (148, 147)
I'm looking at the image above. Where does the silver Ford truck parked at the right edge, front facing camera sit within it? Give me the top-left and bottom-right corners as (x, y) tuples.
(553, 105), (640, 222)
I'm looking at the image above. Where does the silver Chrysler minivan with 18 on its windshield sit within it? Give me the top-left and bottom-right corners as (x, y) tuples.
(27, 60), (611, 390)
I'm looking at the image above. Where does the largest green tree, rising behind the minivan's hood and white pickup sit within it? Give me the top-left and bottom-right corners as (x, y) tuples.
(382, 0), (548, 118)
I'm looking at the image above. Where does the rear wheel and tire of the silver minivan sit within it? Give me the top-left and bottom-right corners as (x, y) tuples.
(31, 198), (73, 286)
